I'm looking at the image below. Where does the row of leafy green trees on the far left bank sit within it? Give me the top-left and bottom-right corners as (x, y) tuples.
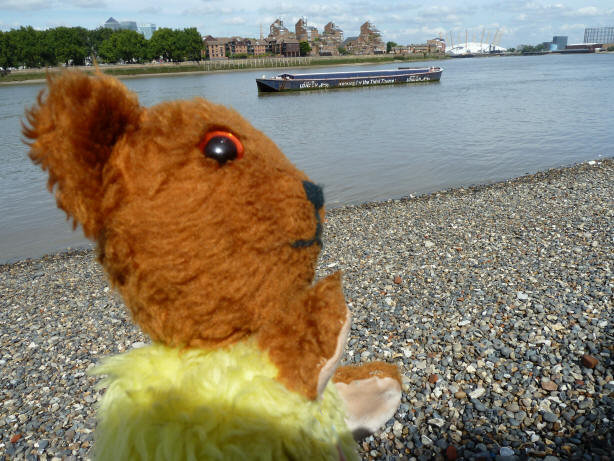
(0, 26), (203, 69)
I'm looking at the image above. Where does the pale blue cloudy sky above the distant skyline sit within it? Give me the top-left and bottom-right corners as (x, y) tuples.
(0, 0), (614, 47)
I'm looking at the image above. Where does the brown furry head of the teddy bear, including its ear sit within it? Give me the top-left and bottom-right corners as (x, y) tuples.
(24, 72), (324, 346)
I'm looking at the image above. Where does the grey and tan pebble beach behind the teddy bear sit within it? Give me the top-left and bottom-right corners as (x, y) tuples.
(0, 158), (614, 461)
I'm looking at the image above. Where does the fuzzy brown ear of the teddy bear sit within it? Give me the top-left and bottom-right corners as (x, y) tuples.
(23, 72), (142, 239)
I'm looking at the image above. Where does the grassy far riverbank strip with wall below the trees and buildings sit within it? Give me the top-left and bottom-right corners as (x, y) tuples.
(0, 54), (447, 85)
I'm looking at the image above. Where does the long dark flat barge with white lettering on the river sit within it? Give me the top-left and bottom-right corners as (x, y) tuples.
(256, 67), (443, 93)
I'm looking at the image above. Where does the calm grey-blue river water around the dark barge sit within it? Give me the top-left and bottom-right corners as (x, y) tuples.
(0, 53), (614, 262)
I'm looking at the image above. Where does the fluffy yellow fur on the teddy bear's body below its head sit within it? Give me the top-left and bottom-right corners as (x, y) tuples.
(93, 341), (357, 460)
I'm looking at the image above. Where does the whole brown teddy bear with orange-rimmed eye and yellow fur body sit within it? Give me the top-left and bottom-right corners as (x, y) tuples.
(23, 71), (401, 460)
